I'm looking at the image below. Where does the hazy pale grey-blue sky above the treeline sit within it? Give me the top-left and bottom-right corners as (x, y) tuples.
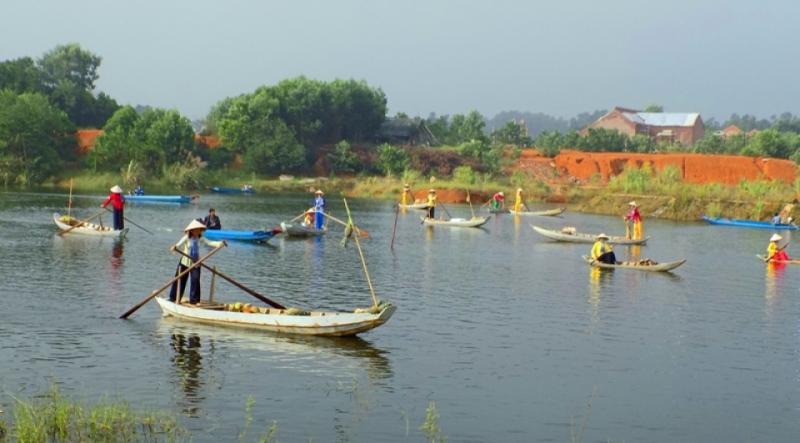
(0, 0), (800, 118)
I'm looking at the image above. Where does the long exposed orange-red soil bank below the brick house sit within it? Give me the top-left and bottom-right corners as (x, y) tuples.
(554, 150), (797, 185)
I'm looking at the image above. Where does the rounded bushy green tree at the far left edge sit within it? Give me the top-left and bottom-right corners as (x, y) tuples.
(0, 90), (75, 186)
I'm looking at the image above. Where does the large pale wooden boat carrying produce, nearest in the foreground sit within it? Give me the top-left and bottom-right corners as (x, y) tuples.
(156, 297), (397, 336)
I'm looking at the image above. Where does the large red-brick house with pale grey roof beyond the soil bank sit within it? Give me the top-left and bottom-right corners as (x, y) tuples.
(581, 107), (705, 146)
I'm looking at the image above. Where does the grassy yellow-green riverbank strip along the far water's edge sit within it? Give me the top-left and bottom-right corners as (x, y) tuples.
(37, 168), (800, 221)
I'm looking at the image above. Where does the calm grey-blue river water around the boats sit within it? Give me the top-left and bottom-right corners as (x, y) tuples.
(0, 193), (800, 442)
